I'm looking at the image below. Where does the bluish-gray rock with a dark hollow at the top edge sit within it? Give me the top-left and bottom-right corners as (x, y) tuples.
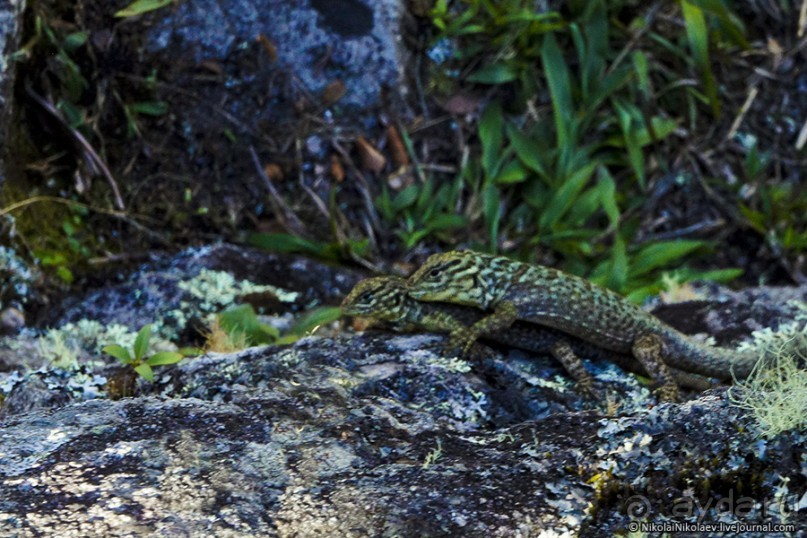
(146, 0), (404, 116)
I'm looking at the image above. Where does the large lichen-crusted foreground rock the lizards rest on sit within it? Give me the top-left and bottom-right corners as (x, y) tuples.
(0, 333), (807, 537)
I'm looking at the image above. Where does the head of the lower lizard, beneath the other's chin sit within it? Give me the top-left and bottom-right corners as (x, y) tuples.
(342, 276), (407, 321)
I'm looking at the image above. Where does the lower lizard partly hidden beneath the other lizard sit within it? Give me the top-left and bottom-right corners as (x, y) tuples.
(342, 276), (711, 393)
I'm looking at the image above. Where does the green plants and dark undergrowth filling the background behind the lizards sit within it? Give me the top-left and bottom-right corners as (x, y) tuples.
(0, 0), (807, 301)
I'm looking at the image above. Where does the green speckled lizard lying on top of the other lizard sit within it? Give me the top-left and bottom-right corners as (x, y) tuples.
(408, 251), (758, 400)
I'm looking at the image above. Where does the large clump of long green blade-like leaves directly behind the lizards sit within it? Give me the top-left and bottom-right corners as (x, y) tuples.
(376, 0), (747, 300)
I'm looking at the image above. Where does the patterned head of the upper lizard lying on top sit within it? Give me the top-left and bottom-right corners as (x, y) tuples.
(407, 251), (490, 308)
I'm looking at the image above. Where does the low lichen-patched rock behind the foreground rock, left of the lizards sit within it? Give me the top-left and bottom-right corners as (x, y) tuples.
(39, 245), (359, 333)
